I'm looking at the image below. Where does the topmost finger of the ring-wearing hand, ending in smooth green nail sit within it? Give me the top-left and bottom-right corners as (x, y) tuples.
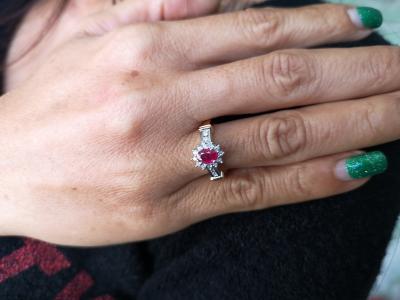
(164, 4), (382, 65)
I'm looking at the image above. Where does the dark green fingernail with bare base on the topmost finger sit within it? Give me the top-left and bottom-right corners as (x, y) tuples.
(348, 6), (383, 29)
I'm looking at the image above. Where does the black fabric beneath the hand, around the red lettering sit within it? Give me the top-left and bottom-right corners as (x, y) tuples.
(0, 0), (400, 300)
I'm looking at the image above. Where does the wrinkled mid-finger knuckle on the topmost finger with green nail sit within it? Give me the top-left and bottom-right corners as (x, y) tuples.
(236, 9), (282, 50)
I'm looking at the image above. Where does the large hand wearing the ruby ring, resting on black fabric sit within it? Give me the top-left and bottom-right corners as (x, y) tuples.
(0, 5), (400, 245)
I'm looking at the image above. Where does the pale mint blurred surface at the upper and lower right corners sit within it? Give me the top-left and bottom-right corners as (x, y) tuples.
(331, 0), (400, 300)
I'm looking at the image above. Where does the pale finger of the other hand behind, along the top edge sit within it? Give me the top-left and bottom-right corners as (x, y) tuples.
(83, 0), (219, 36)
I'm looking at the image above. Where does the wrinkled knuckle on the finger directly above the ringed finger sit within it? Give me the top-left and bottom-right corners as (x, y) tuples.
(263, 51), (318, 99)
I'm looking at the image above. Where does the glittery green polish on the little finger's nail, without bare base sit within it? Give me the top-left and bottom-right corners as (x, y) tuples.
(346, 151), (388, 179)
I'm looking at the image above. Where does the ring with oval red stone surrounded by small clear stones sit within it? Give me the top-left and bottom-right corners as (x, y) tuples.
(192, 123), (224, 180)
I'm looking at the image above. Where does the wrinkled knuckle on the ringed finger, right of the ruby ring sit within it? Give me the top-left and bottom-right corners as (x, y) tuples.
(254, 113), (308, 161)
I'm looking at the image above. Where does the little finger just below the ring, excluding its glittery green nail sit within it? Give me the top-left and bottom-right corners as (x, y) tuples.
(166, 153), (368, 225)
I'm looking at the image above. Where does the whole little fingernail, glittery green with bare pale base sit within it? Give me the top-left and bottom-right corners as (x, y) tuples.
(335, 151), (388, 181)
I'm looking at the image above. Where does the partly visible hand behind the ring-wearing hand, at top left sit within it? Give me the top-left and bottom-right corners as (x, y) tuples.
(5, 0), (260, 90)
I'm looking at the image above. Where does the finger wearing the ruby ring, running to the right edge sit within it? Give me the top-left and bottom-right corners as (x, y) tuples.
(186, 93), (400, 173)
